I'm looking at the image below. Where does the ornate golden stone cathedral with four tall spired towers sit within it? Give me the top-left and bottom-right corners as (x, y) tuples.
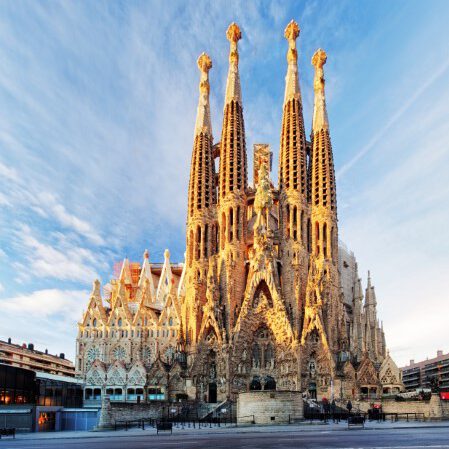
(76, 21), (402, 403)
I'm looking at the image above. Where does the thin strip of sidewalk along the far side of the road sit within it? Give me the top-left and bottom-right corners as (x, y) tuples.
(12, 421), (449, 440)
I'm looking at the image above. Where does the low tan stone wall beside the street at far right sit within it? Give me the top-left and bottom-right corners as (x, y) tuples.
(357, 394), (449, 419)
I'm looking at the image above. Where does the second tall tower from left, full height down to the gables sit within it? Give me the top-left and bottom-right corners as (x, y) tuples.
(218, 23), (248, 331)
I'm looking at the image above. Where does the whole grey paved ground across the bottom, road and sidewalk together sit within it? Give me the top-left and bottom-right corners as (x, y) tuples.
(0, 422), (449, 449)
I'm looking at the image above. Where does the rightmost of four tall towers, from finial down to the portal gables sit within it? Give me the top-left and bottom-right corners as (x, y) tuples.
(310, 49), (343, 351)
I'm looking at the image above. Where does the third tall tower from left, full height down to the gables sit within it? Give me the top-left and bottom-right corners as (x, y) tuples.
(279, 20), (309, 331)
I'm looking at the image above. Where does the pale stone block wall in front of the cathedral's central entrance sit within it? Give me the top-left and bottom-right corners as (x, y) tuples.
(237, 391), (304, 424)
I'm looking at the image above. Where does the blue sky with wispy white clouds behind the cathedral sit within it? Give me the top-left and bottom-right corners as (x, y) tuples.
(0, 0), (449, 364)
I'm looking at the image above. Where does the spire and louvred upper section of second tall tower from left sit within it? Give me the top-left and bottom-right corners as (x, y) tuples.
(219, 23), (247, 201)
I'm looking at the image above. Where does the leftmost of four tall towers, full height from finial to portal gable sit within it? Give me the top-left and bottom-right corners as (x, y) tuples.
(183, 53), (217, 345)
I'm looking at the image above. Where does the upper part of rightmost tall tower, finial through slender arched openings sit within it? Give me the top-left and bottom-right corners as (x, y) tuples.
(311, 48), (338, 264)
